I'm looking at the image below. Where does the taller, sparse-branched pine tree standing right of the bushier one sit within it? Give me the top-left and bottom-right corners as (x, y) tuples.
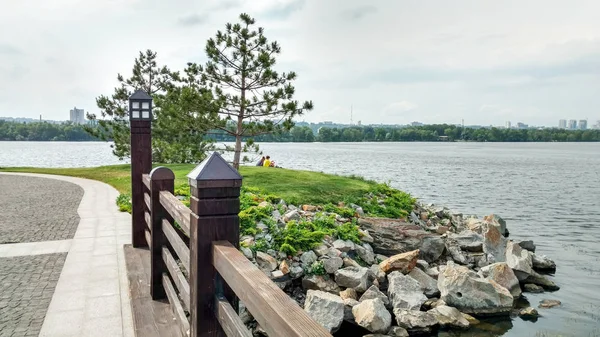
(202, 13), (313, 168)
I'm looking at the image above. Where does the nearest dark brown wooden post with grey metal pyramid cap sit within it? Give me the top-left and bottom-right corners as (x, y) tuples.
(188, 152), (242, 337)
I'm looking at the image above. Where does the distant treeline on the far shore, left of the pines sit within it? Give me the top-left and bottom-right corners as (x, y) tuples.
(0, 120), (98, 142)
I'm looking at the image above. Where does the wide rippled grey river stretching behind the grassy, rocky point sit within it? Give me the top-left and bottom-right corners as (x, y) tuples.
(0, 142), (600, 337)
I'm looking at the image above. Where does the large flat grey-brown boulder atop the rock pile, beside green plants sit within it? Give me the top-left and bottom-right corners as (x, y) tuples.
(358, 218), (436, 255)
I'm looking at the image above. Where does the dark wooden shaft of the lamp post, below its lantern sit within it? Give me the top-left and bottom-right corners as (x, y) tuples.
(131, 120), (152, 248)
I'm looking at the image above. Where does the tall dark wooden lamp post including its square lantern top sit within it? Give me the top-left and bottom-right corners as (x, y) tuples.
(129, 89), (152, 248)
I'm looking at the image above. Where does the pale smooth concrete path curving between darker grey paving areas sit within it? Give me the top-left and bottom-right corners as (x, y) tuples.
(0, 173), (134, 337)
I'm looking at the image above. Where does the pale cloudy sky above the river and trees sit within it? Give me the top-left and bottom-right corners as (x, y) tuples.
(0, 0), (600, 126)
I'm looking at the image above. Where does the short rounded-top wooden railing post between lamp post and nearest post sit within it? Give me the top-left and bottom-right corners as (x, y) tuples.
(150, 166), (175, 300)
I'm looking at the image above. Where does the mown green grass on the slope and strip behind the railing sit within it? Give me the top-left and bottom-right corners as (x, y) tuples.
(0, 164), (375, 204)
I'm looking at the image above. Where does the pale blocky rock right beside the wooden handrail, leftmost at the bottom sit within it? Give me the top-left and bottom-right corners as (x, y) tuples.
(304, 290), (344, 332)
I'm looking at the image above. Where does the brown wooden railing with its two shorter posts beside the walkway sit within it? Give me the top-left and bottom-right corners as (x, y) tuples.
(133, 153), (331, 337)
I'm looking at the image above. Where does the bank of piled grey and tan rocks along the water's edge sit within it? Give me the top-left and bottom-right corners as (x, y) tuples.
(241, 198), (559, 337)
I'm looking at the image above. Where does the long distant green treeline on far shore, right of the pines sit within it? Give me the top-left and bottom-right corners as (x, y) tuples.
(211, 124), (600, 142)
